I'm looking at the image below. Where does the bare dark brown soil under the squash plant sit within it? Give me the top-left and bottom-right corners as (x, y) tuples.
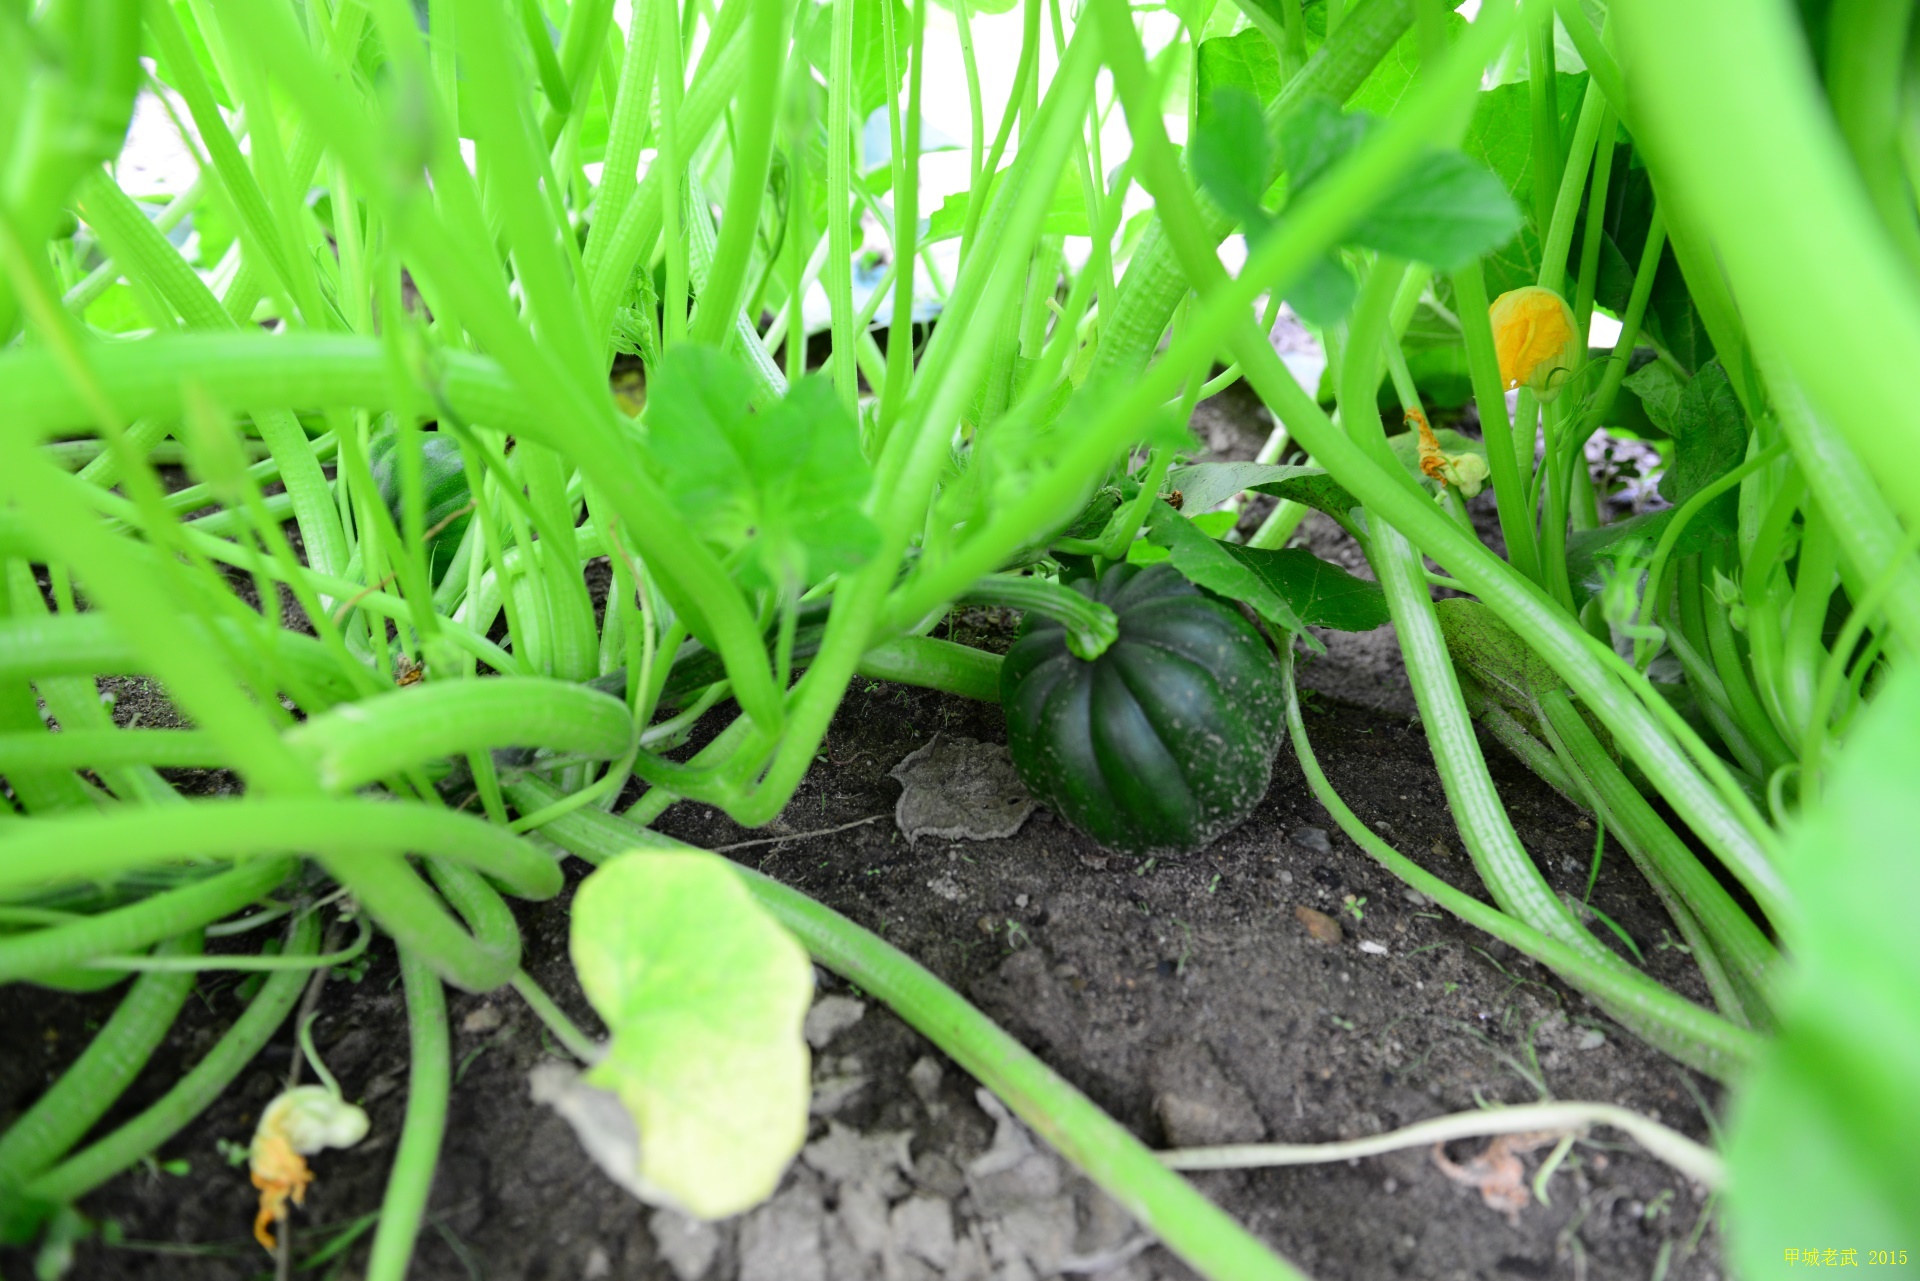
(0, 386), (1722, 1281)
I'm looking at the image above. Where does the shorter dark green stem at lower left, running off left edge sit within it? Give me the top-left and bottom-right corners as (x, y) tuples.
(0, 930), (202, 1200)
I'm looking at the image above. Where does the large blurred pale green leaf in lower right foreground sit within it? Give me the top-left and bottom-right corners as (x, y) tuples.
(1728, 665), (1920, 1277)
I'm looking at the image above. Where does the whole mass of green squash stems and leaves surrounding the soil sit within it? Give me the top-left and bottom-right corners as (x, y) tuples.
(0, 0), (1920, 1279)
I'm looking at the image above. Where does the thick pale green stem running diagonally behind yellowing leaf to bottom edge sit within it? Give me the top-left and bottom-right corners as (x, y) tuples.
(509, 780), (1300, 1281)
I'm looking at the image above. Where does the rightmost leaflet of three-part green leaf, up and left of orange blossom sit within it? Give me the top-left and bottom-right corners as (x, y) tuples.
(1352, 152), (1521, 271)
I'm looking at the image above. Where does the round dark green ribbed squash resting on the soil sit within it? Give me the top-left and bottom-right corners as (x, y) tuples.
(1000, 563), (1284, 855)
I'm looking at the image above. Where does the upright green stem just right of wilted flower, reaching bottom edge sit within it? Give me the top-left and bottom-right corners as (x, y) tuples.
(367, 947), (453, 1281)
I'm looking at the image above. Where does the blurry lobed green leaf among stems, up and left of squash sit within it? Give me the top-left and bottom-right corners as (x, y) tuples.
(647, 344), (879, 588)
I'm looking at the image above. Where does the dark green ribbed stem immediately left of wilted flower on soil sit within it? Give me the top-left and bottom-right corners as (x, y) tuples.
(21, 914), (321, 1204)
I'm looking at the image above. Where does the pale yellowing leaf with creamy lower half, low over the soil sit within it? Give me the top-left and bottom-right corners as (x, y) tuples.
(572, 851), (814, 1218)
